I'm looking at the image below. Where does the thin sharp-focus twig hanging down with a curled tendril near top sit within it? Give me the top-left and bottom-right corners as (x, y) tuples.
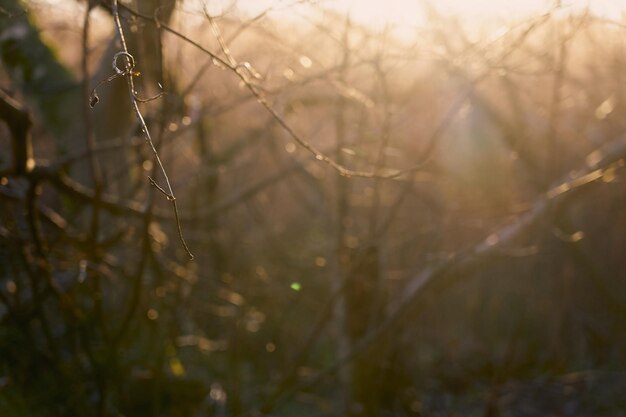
(112, 0), (194, 259)
